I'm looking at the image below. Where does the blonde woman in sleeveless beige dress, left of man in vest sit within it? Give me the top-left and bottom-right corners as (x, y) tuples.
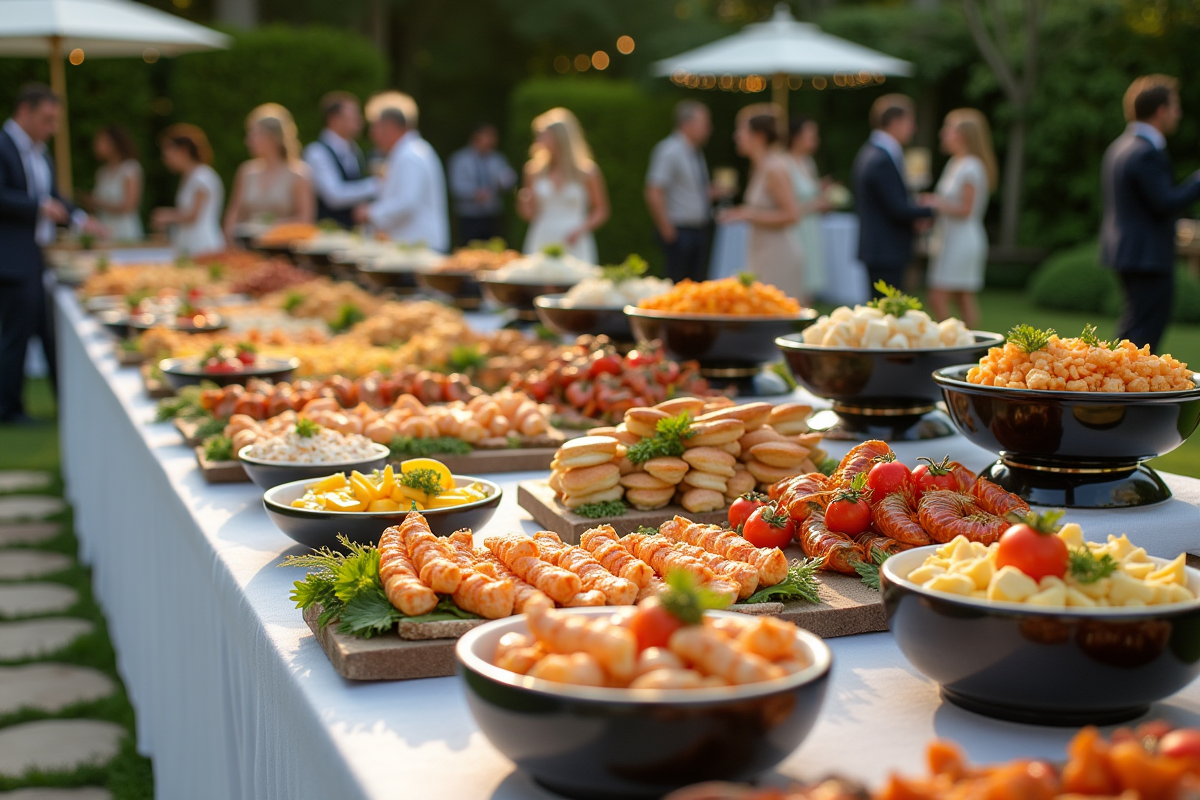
(224, 103), (317, 243)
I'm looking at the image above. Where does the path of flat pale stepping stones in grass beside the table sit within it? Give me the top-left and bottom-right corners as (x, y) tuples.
(0, 470), (127, 800)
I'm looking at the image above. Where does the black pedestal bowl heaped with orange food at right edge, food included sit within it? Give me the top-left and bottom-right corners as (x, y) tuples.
(934, 326), (1200, 507)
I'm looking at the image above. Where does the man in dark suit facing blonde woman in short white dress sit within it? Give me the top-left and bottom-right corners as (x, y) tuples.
(853, 95), (934, 296)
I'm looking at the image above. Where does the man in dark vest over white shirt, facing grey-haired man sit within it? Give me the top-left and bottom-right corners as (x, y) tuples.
(304, 91), (378, 228)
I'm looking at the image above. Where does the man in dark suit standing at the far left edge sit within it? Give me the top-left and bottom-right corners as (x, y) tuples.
(0, 84), (103, 425)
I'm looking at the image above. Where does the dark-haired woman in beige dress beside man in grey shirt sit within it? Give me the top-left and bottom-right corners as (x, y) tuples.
(720, 103), (806, 297)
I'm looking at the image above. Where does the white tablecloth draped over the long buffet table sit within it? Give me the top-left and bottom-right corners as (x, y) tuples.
(56, 289), (1200, 800)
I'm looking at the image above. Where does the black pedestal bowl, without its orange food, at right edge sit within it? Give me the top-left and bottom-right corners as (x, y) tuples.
(932, 365), (1200, 507)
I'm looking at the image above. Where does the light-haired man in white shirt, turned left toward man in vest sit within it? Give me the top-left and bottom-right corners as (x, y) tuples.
(354, 92), (450, 253)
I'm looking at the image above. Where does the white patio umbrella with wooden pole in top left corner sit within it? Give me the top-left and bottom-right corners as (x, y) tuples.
(0, 0), (229, 194)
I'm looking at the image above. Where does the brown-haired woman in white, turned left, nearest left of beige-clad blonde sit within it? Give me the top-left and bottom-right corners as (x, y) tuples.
(150, 122), (224, 255)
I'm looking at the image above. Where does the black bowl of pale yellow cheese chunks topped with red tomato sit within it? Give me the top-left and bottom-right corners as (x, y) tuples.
(880, 512), (1200, 726)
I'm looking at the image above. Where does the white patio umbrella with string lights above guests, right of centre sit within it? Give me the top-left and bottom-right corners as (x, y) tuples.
(654, 2), (912, 119)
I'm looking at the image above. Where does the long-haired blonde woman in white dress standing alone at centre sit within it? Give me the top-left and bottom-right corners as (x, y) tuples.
(517, 108), (608, 264)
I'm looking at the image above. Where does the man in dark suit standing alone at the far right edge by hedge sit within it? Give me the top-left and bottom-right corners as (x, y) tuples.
(1100, 76), (1200, 351)
